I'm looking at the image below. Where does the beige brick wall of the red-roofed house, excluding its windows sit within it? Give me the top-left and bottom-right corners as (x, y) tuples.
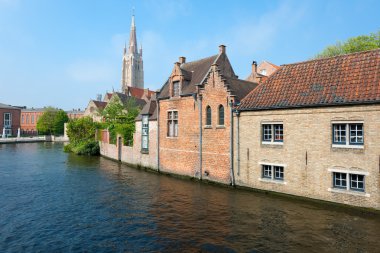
(234, 105), (380, 209)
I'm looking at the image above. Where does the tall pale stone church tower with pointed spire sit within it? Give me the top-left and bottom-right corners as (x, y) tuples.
(121, 15), (144, 93)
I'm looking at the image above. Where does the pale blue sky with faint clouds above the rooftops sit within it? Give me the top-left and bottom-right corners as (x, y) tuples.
(0, 0), (380, 110)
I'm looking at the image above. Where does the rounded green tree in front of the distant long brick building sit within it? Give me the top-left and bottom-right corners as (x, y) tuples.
(37, 107), (69, 135)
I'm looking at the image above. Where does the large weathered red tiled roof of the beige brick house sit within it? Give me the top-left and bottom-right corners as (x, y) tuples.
(239, 49), (380, 110)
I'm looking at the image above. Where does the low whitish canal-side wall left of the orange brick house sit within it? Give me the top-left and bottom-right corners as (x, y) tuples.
(99, 121), (157, 170)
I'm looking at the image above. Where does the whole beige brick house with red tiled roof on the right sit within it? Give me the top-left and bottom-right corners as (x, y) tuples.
(234, 49), (380, 209)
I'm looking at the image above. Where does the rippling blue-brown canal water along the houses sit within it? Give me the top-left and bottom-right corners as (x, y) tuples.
(0, 143), (380, 252)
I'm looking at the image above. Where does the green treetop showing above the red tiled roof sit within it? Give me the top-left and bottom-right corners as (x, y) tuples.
(314, 31), (380, 59)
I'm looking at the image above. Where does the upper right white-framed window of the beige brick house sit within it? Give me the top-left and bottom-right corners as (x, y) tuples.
(333, 123), (364, 146)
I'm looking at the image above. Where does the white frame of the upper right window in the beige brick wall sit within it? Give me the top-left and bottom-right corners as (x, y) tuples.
(331, 121), (364, 149)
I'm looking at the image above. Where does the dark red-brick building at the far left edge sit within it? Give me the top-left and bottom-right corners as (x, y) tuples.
(0, 103), (21, 137)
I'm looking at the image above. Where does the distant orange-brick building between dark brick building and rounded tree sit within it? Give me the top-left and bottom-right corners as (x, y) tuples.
(21, 108), (46, 135)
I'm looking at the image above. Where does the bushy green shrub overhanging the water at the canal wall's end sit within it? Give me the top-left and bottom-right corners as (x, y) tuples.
(64, 117), (99, 155)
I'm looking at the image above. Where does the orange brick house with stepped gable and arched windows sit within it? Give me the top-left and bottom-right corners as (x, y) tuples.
(158, 45), (257, 183)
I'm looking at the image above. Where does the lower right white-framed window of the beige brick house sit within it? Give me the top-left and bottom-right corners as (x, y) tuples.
(333, 172), (365, 192)
